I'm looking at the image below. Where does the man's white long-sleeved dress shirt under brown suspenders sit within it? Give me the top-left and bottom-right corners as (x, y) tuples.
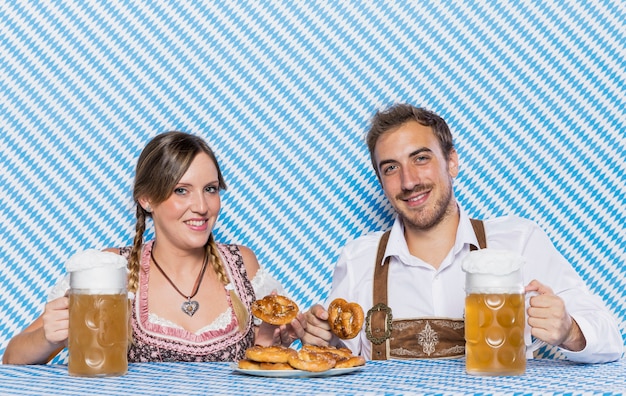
(327, 208), (624, 363)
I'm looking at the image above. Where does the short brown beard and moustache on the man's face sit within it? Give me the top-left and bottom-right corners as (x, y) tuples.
(396, 183), (452, 231)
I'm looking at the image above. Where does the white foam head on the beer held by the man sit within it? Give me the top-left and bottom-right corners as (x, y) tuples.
(461, 249), (524, 293)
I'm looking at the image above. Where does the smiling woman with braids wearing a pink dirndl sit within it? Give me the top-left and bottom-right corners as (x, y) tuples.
(3, 132), (293, 364)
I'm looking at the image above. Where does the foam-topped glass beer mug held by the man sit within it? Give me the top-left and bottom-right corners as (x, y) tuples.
(462, 249), (540, 375)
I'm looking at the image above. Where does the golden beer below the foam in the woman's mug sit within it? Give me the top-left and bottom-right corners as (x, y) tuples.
(68, 290), (128, 377)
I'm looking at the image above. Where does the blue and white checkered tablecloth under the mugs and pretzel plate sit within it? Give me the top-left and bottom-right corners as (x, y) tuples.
(0, 360), (626, 396)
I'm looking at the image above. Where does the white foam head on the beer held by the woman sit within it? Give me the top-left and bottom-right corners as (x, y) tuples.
(65, 249), (127, 293)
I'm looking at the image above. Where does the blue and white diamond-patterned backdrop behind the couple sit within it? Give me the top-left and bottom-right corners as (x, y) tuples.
(0, 0), (626, 362)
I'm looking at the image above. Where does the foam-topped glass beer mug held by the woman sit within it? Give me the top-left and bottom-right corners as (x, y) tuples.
(67, 250), (129, 377)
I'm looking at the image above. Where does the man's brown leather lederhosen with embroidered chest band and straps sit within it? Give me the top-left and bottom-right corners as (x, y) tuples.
(365, 219), (487, 360)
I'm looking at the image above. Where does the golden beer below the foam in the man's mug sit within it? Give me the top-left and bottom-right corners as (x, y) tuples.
(465, 293), (526, 375)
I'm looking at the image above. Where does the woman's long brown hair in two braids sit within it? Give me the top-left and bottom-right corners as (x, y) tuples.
(128, 131), (249, 330)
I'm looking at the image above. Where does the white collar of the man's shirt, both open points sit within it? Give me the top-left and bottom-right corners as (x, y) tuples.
(383, 203), (478, 265)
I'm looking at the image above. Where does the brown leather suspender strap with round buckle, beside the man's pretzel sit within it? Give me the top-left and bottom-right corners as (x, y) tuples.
(365, 231), (392, 360)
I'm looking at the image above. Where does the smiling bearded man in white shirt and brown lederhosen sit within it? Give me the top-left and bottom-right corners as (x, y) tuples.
(294, 104), (623, 363)
